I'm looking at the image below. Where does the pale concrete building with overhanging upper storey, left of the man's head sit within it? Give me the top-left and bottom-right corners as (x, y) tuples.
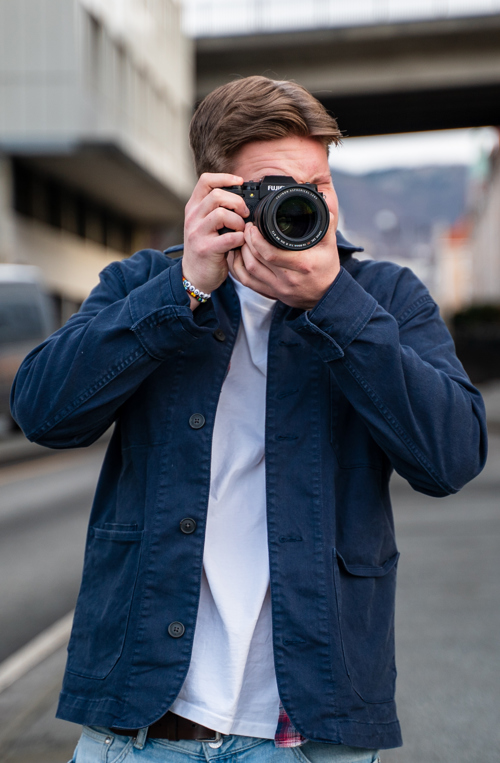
(0, 0), (194, 319)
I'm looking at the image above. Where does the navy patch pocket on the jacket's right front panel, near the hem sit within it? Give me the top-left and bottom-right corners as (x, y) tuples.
(333, 549), (399, 703)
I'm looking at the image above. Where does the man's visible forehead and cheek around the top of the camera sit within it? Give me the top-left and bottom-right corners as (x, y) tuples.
(230, 136), (338, 230)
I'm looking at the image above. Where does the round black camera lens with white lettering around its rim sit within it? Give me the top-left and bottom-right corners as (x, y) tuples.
(253, 185), (330, 251)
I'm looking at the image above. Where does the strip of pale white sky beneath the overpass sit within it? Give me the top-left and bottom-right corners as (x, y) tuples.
(330, 127), (498, 174)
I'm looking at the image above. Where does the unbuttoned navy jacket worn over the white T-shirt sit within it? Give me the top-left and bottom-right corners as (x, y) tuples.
(12, 237), (486, 748)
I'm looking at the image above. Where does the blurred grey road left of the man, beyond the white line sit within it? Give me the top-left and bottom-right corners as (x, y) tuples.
(0, 445), (104, 662)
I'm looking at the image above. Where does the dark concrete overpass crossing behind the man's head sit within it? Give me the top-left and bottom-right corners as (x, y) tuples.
(196, 14), (500, 136)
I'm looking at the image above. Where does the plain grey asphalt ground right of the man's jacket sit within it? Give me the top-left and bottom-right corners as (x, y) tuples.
(382, 435), (500, 763)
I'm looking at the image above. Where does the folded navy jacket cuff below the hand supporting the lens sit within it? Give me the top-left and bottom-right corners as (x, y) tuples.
(288, 268), (378, 363)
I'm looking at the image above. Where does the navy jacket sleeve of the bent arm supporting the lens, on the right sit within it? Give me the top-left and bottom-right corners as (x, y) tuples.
(290, 263), (487, 496)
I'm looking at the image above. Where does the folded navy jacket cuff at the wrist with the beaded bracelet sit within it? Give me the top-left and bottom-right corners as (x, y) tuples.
(129, 260), (218, 360)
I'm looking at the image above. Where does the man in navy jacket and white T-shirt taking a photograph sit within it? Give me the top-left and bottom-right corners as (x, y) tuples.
(13, 77), (486, 763)
